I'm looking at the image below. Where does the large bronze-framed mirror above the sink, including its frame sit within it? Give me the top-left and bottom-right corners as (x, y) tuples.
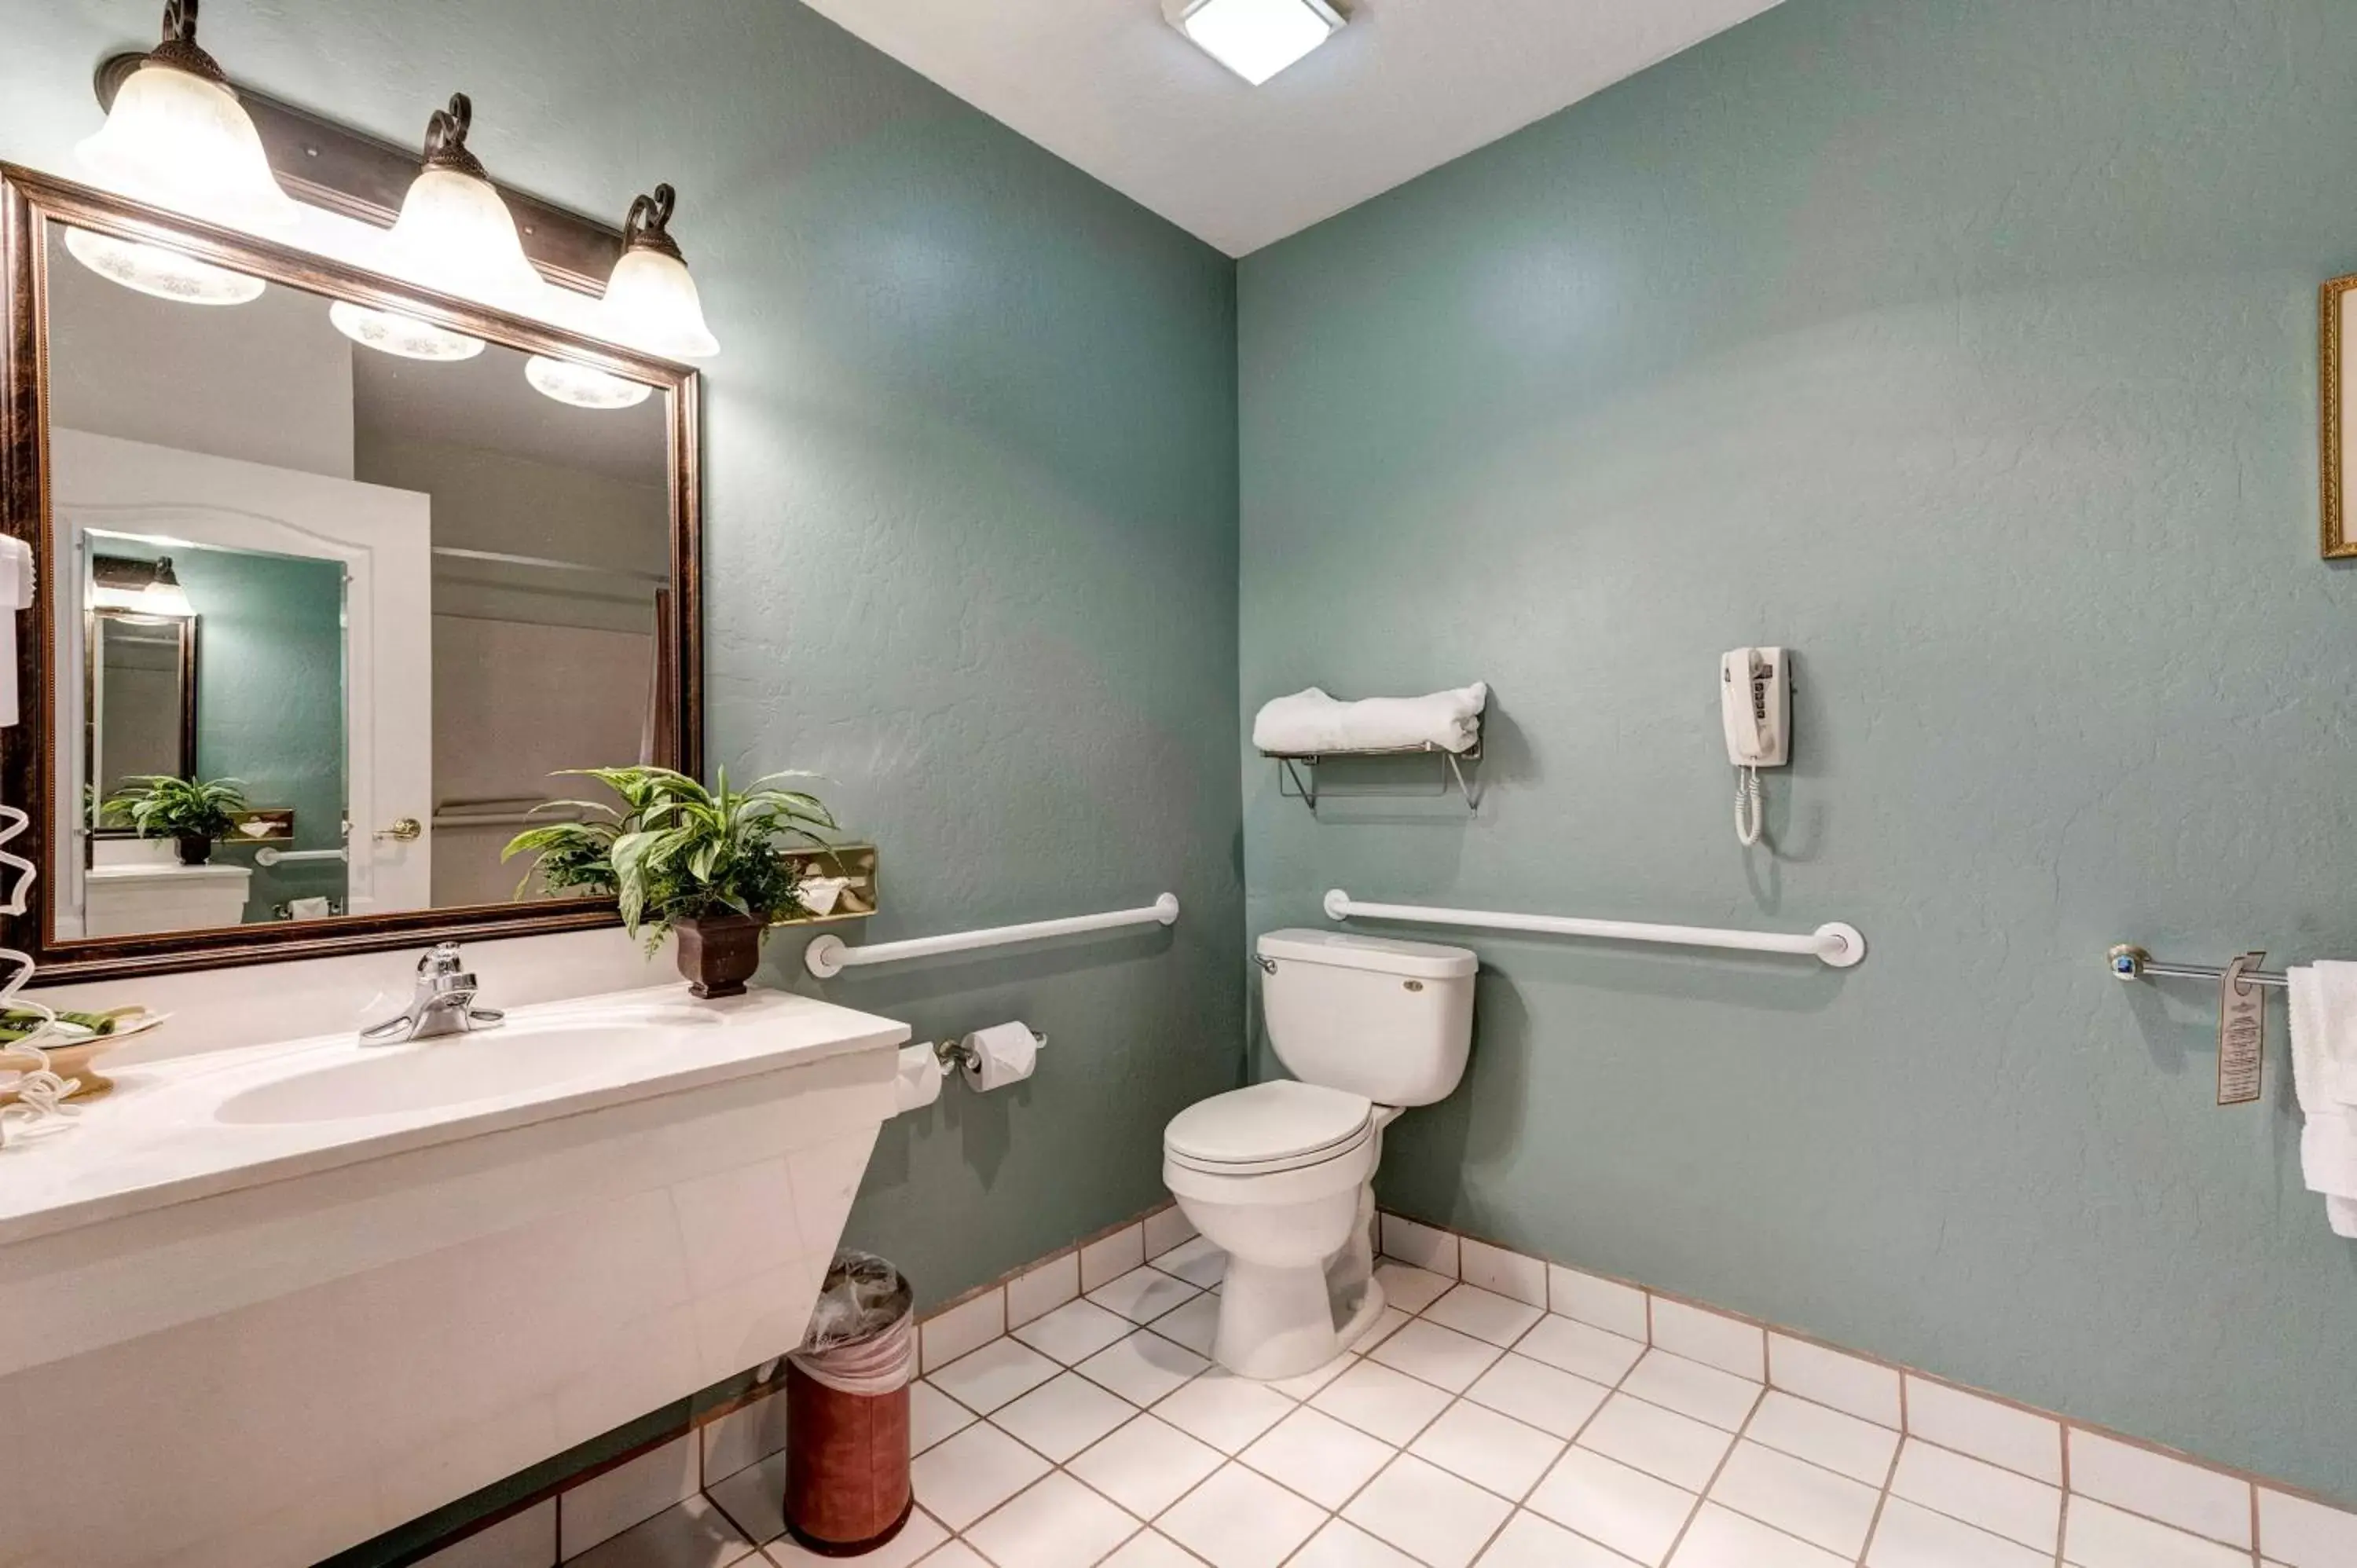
(0, 170), (700, 979)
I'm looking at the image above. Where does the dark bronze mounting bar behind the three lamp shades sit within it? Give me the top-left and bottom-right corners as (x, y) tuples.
(92, 52), (622, 299)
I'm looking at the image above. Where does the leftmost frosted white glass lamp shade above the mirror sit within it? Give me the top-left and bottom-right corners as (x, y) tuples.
(75, 61), (297, 233)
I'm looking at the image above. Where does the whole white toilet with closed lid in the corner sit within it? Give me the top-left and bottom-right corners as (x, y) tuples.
(1162, 932), (1480, 1379)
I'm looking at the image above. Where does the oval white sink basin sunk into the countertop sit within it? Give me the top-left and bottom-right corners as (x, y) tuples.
(214, 1009), (719, 1125)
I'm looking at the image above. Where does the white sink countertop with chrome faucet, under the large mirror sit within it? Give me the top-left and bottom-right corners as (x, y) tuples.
(0, 984), (910, 1245)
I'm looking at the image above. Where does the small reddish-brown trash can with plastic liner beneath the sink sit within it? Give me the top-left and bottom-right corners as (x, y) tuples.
(785, 1252), (917, 1556)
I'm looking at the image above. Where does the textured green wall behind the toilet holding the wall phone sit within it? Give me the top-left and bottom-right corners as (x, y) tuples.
(1240, 0), (2357, 1500)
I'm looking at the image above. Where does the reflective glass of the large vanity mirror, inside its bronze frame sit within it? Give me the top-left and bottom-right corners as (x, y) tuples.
(45, 229), (674, 941)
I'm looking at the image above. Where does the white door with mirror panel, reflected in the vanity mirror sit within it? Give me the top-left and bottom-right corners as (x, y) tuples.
(49, 429), (431, 936)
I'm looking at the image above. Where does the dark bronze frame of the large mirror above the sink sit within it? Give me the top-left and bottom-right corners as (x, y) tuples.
(0, 163), (705, 986)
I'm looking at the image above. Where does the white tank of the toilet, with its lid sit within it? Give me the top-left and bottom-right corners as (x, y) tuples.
(1259, 932), (1480, 1106)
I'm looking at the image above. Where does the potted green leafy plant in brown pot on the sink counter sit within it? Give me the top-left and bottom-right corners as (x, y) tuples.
(500, 766), (834, 998)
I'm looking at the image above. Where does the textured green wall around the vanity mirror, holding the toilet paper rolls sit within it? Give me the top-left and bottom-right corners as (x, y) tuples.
(0, 0), (1242, 1299)
